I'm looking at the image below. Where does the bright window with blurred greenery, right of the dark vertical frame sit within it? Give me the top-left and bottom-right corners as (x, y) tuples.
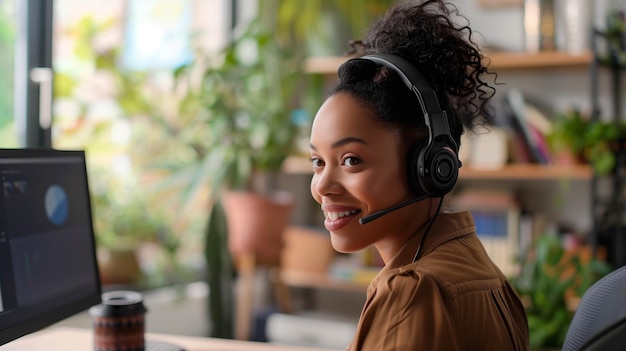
(52, 0), (232, 286)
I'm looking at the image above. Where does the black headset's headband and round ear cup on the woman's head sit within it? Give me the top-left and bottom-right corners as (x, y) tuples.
(361, 54), (461, 197)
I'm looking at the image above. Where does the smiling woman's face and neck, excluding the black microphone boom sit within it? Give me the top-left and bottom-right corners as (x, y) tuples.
(311, 93), (423, 253)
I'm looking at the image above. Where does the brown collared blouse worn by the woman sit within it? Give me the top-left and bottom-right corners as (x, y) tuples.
(348, 212), (528, 351)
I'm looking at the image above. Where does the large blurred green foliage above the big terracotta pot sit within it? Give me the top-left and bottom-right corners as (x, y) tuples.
(176, 20), (306, 199)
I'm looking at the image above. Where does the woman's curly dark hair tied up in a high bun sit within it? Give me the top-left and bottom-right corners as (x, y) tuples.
(330, 0), (495, 145)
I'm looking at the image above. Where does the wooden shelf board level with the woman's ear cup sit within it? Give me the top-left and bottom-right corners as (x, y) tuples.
(283, 157), (593, 181)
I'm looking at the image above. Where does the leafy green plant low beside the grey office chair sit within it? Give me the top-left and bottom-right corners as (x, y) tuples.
(511, 235), (611, 350)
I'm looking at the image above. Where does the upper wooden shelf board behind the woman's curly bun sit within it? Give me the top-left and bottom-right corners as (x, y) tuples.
(305, 51), (593, 74)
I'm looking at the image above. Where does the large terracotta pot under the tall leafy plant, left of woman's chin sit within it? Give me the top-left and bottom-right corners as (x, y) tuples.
(223, 191), (293, 264)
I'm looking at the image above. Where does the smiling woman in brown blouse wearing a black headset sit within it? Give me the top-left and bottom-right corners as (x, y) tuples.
(311, 1), (528, 351)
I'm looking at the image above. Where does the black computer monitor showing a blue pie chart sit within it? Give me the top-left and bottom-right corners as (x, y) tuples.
(0, 149), (101, 345)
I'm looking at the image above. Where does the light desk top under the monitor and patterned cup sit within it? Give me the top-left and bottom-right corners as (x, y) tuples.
(0, 327), (336, 351)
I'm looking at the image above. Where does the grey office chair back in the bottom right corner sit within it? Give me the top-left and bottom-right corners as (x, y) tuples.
(563, 266), (626, 351)
